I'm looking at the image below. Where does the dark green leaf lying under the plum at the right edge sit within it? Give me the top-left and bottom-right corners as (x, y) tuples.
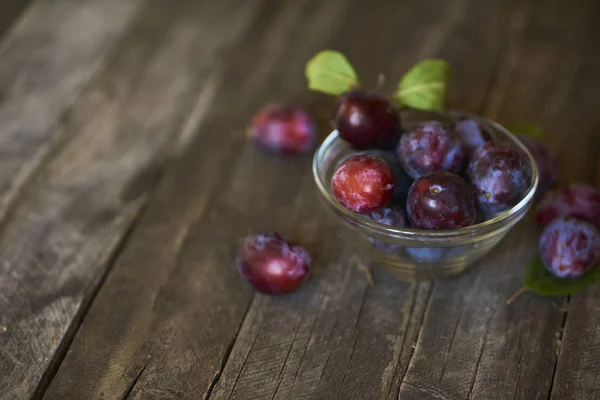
(523, 256), (600, 296)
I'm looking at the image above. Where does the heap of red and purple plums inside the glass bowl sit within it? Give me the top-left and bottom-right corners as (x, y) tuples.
(331, 90), (532, 238)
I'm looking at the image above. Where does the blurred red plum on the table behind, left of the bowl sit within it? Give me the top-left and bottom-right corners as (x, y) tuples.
(248, 104), (317, 155)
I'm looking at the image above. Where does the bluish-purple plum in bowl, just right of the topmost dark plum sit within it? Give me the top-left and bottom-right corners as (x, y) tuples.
(396, 121), (464, 179)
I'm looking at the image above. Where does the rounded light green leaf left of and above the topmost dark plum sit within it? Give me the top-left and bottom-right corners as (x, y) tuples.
(305, 50), (360, 96)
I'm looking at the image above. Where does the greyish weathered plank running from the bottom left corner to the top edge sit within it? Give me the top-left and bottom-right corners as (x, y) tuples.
(0, 0), (260, 400)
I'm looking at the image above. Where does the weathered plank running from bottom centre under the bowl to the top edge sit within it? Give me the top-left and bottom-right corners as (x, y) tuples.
(212, 1), (510, 399)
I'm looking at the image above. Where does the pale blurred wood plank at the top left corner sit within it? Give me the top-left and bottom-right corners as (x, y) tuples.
(0, 0), (140, 219)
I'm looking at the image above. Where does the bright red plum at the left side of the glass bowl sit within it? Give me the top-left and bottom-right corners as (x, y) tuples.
(331, 154), (394, 213)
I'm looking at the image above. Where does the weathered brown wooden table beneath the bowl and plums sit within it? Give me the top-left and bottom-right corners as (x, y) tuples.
(0, 0), (600, 400)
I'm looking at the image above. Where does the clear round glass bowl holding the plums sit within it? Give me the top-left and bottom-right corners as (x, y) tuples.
(312, 110), (538, 281)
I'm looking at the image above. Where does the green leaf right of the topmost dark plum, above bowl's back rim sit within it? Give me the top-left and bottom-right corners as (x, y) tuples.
(394, 59), (451, 111)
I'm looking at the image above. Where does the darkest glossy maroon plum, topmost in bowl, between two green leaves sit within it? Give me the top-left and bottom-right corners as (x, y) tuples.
(335, 89), (401, 150)
